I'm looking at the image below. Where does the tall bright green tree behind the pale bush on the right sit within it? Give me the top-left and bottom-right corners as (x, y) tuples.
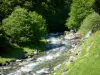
(66, 0), (95, 30)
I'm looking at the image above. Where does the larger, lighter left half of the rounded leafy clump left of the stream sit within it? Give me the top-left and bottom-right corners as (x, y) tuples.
(3, 7), (29, 41)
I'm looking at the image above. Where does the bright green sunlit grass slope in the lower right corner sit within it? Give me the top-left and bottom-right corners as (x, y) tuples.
(67, 31), (100, 75)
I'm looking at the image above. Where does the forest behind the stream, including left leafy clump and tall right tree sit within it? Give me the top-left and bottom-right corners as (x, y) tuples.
(0, 0), (100, 50)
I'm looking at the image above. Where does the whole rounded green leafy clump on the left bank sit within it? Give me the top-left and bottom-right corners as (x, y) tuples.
(2, 7), (46, 42)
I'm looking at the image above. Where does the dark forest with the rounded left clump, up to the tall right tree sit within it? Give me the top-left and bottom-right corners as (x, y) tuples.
(0, 0), (72, 54)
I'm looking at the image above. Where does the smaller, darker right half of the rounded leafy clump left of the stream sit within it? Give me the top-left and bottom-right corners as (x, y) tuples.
(29, 12), (47, 42)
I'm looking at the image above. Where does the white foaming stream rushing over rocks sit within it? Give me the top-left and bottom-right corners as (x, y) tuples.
(2, 33), (74, 75)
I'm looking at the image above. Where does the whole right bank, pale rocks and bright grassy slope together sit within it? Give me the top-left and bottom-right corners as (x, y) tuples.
(51, 30), (100, 75)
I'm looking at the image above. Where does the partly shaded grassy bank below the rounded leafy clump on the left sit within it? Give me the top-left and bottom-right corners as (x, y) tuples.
(0, 40), (46, 64)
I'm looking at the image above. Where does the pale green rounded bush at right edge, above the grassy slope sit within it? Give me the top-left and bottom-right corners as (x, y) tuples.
(79, 12), (100, 36)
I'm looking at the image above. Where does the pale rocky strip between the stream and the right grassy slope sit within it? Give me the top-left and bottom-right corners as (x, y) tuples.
(51, 32), (82, 75)
